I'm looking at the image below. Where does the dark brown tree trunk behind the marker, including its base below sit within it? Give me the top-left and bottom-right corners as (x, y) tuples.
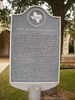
(42, 1), (65, 96)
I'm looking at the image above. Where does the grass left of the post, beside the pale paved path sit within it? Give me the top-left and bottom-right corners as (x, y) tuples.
(0, 67), (28, 100)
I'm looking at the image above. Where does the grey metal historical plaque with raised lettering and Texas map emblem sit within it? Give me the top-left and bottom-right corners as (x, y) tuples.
(11, 6), (60, 87)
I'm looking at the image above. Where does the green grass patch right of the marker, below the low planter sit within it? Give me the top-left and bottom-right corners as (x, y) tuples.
(58, 69), (75, 92)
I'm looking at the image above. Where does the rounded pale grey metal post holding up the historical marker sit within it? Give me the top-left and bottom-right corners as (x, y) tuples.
(29, 86), (41, 100)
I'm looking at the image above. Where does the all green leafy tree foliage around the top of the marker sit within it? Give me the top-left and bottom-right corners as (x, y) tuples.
(0, 0), (75, 34)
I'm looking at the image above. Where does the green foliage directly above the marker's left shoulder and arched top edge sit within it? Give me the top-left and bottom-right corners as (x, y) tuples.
(8, 0), (44, 14)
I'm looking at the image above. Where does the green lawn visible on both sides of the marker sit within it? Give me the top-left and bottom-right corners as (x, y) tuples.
(0, 67), (75, 100)
